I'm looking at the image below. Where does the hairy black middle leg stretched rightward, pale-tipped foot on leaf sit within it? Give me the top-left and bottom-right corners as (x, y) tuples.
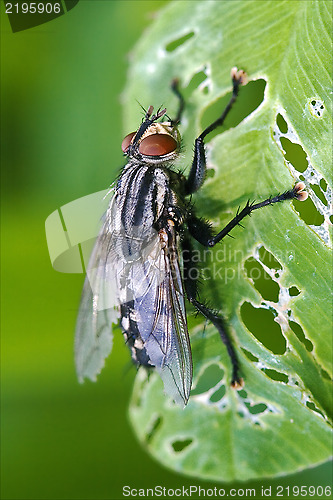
(187, 182), (308, 247)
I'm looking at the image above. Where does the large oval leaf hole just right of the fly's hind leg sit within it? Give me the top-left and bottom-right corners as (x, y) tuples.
(241, 302), (286, 354)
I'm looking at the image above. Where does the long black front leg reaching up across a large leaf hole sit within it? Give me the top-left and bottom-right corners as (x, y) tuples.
(185, 68), (246, 195)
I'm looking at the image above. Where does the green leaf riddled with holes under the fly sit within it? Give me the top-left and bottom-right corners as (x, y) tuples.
(124, 0), (332, 481)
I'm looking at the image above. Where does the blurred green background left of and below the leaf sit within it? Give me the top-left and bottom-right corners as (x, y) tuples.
(1, 0), (330, 499)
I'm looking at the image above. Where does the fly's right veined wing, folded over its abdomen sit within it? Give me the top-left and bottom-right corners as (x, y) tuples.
(132, 230), (192, 406)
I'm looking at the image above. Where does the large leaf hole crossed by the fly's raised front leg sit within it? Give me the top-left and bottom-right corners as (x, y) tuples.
(201, 79), (266, 143)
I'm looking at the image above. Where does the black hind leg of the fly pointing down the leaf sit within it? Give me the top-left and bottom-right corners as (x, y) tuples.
(182, 237), (243, 388)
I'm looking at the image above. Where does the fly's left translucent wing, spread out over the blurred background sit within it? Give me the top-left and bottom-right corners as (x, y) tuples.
(75, 193), (119, 382)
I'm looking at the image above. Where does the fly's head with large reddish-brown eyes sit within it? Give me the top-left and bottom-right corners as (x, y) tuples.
(121, 106), (180, 164)
